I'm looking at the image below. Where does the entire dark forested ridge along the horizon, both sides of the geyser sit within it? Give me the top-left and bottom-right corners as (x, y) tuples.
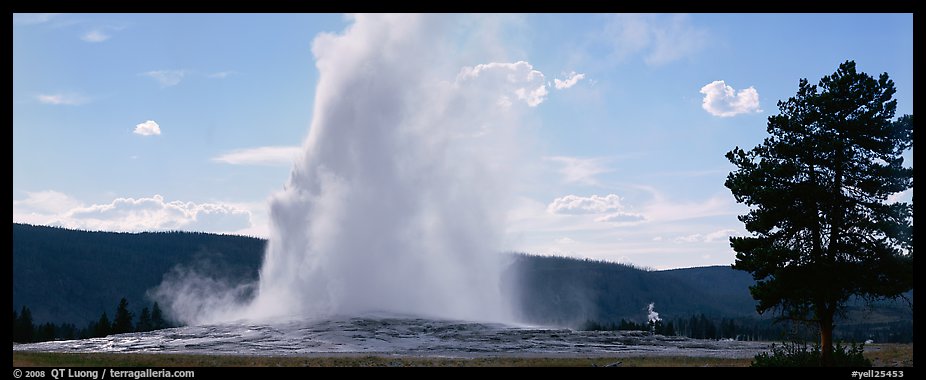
(13, 223), (912, 340)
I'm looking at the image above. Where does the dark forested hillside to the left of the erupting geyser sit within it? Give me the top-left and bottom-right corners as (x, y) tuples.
(13, 223), (266, 326)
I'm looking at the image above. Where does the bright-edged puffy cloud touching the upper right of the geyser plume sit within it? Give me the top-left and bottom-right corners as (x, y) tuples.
(457, 61), (549, 107)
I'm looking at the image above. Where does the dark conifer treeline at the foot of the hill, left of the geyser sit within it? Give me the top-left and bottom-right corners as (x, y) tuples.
(13, 298), (173, 343)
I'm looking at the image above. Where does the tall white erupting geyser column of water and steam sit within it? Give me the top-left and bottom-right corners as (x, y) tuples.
(158, 15), (547, 323)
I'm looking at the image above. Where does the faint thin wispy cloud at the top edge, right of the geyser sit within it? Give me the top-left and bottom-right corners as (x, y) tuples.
(601, 14), (710, 65)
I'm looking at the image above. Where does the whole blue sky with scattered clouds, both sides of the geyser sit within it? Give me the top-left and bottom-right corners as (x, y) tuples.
(13, 14), (913, 268)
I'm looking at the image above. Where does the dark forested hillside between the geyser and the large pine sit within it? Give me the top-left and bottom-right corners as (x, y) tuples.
(506, 254), (757, 326)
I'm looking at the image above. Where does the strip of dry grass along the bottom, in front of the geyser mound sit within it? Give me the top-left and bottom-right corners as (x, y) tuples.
(13, 344), (913, 367)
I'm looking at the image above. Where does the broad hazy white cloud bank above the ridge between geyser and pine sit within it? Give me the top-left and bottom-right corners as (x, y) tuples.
(503, 193), (742, 269)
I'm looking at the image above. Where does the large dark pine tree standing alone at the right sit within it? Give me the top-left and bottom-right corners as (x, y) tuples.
(725, 61), (913, 365)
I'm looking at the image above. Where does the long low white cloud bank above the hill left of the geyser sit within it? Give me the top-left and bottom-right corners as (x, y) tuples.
(13, 191), (253, 233)
